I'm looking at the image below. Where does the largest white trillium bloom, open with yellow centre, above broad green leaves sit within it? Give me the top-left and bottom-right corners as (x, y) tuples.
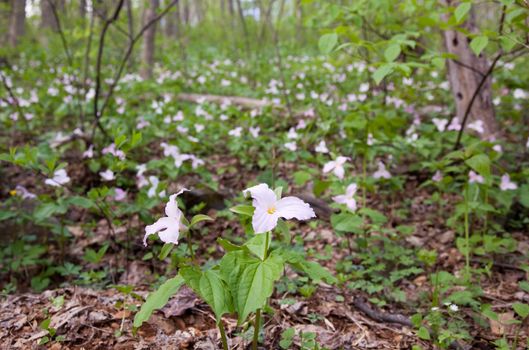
(243, 184), (316, 233)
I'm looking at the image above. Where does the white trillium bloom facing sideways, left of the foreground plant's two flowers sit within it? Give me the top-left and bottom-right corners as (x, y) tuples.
(143, 188), (188, 246)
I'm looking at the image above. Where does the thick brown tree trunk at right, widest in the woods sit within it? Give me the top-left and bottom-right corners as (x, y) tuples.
(443, 0), (499, 138)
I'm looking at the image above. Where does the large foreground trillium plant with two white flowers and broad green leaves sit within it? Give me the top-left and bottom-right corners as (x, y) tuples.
(134, 184), (335, 350)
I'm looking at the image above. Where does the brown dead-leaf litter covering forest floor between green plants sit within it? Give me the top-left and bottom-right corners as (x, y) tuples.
(0, 159), (529, 350)
